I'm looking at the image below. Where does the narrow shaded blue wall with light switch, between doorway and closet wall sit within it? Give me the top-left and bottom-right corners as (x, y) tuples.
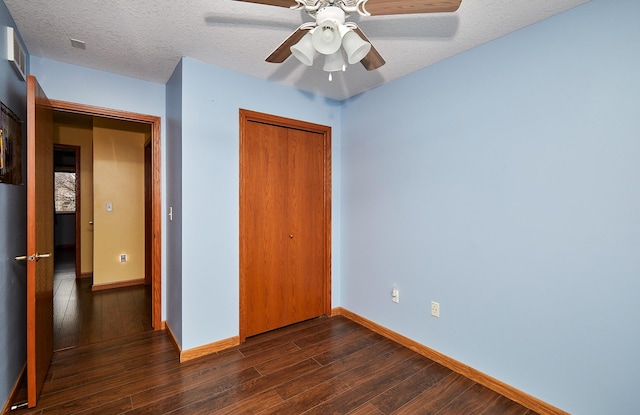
(163, 62), (183, 346)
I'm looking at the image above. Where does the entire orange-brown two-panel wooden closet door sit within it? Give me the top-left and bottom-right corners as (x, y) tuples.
(240, 110), (329, 340)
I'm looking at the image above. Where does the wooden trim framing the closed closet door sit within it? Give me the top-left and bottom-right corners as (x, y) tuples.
(239, 108), (332, 343)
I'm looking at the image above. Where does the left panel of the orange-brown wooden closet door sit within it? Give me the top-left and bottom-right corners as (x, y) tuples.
(241, 122), (290, 336)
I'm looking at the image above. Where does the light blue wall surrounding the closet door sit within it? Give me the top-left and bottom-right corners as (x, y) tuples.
(178, 58), (341, 349)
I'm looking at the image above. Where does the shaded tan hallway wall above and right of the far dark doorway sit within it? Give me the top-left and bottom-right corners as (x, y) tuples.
(53, 120), (93, 274)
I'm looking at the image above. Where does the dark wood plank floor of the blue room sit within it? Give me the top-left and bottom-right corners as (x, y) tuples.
(15, 317), (534, 415)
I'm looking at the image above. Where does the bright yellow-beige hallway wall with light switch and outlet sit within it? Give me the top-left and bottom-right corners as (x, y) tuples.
(93, 118), (148, 286)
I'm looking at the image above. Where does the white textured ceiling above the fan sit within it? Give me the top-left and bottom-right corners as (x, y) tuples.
(4, 0), (588, 100)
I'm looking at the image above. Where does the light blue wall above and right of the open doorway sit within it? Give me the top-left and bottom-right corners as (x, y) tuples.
(30, 56), (167, 320)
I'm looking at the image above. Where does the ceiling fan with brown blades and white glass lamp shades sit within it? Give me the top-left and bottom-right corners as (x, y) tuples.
(239, 0), (462, 80)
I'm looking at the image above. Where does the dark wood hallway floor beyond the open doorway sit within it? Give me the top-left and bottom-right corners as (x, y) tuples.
(53, 248), (152, 350)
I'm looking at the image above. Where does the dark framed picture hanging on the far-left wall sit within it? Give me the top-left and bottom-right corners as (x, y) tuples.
(0, 103), (22, 184)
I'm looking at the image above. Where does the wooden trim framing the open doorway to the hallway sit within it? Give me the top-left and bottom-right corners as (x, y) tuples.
(50, 100), (163, 330)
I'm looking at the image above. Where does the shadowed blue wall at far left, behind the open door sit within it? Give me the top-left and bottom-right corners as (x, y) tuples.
(0, 2), (27, 408)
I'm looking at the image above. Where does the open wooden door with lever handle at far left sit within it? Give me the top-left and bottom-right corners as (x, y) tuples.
(27, 76), (53, 408)
